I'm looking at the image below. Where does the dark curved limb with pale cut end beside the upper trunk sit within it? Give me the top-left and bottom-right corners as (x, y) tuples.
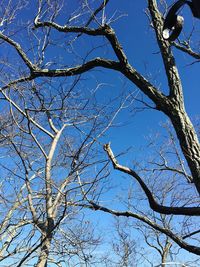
(163, 0), (200, 41)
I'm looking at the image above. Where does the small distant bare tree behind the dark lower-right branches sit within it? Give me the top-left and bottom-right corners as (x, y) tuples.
(94, 124), (199, 267)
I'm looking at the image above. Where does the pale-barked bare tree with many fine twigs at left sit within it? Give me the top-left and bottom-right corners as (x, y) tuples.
(0, 1), (133, 267)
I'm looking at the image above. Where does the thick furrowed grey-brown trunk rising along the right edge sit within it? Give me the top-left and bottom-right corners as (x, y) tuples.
(148, 0), (200, 194)
